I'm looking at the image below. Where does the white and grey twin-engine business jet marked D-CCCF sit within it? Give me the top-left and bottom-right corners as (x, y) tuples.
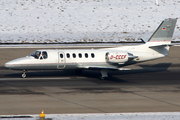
(4, 18), (177, 78)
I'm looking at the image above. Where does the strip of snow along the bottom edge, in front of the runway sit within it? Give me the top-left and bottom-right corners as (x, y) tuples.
(0, 112), (180, 120)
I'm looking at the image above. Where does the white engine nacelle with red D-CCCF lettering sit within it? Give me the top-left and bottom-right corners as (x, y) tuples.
(105, 52), (128, 63)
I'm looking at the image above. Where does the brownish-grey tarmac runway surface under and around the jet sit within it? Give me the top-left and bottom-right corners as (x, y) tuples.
(0, 46), (180, 115)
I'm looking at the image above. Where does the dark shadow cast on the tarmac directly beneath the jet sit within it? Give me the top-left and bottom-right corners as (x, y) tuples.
(4, 63), (171, 82)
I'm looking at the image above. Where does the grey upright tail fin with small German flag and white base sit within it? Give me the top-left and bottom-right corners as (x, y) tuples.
(148, 18), (177, 45)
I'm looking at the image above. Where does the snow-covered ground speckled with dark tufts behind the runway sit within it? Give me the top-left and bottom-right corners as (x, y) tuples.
(0, 0), (180, 43)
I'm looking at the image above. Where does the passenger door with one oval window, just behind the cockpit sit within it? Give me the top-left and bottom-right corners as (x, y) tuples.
(57, 51), (66, 69)
